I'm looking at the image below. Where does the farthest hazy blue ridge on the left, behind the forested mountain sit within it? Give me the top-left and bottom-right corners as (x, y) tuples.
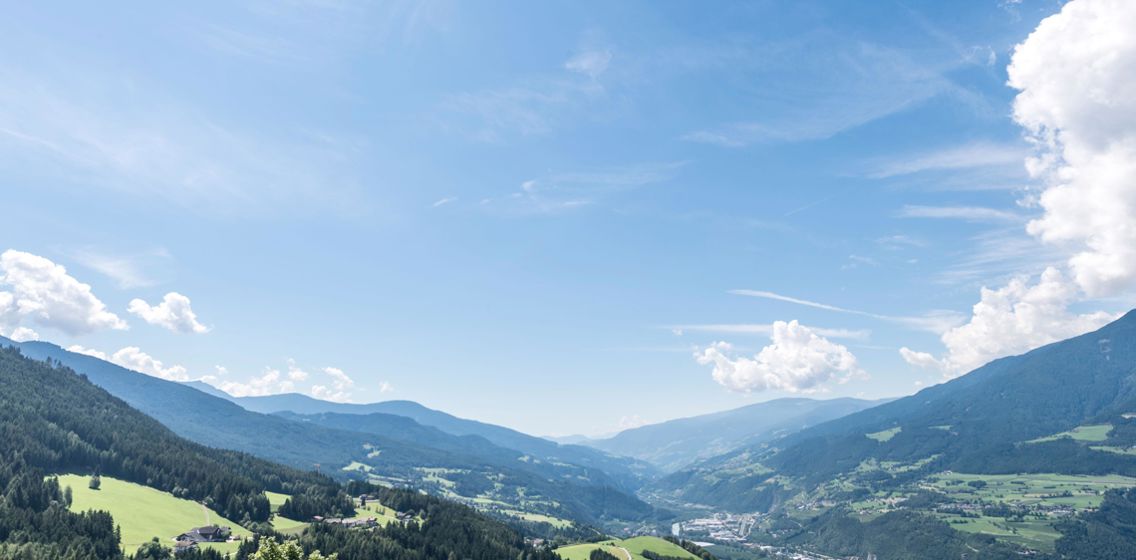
(210, 387), (655, 490)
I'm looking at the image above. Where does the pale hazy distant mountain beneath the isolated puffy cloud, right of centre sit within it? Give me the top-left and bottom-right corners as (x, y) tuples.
(582, 399), (886, 471)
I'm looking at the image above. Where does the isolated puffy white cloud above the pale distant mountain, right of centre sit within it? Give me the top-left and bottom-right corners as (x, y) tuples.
(694, 320), (861, 393)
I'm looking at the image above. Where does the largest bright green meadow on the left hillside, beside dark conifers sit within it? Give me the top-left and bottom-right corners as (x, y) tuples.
(59, 475), (251, 554)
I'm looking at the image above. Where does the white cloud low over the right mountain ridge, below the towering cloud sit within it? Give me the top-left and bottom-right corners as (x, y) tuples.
(900, 267), (1117, 377)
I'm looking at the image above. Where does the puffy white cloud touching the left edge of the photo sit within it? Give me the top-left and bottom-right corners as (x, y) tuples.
(0, 249), (127, 335)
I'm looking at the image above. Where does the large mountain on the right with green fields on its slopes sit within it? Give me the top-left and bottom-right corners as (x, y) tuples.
(650, 311), (1136, 559)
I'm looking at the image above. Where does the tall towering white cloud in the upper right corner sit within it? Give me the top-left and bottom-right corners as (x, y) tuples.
(1008, 0), (1136, 296)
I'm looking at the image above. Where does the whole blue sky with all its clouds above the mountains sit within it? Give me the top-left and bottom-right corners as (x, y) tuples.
(0, 0), (1136, 435)
